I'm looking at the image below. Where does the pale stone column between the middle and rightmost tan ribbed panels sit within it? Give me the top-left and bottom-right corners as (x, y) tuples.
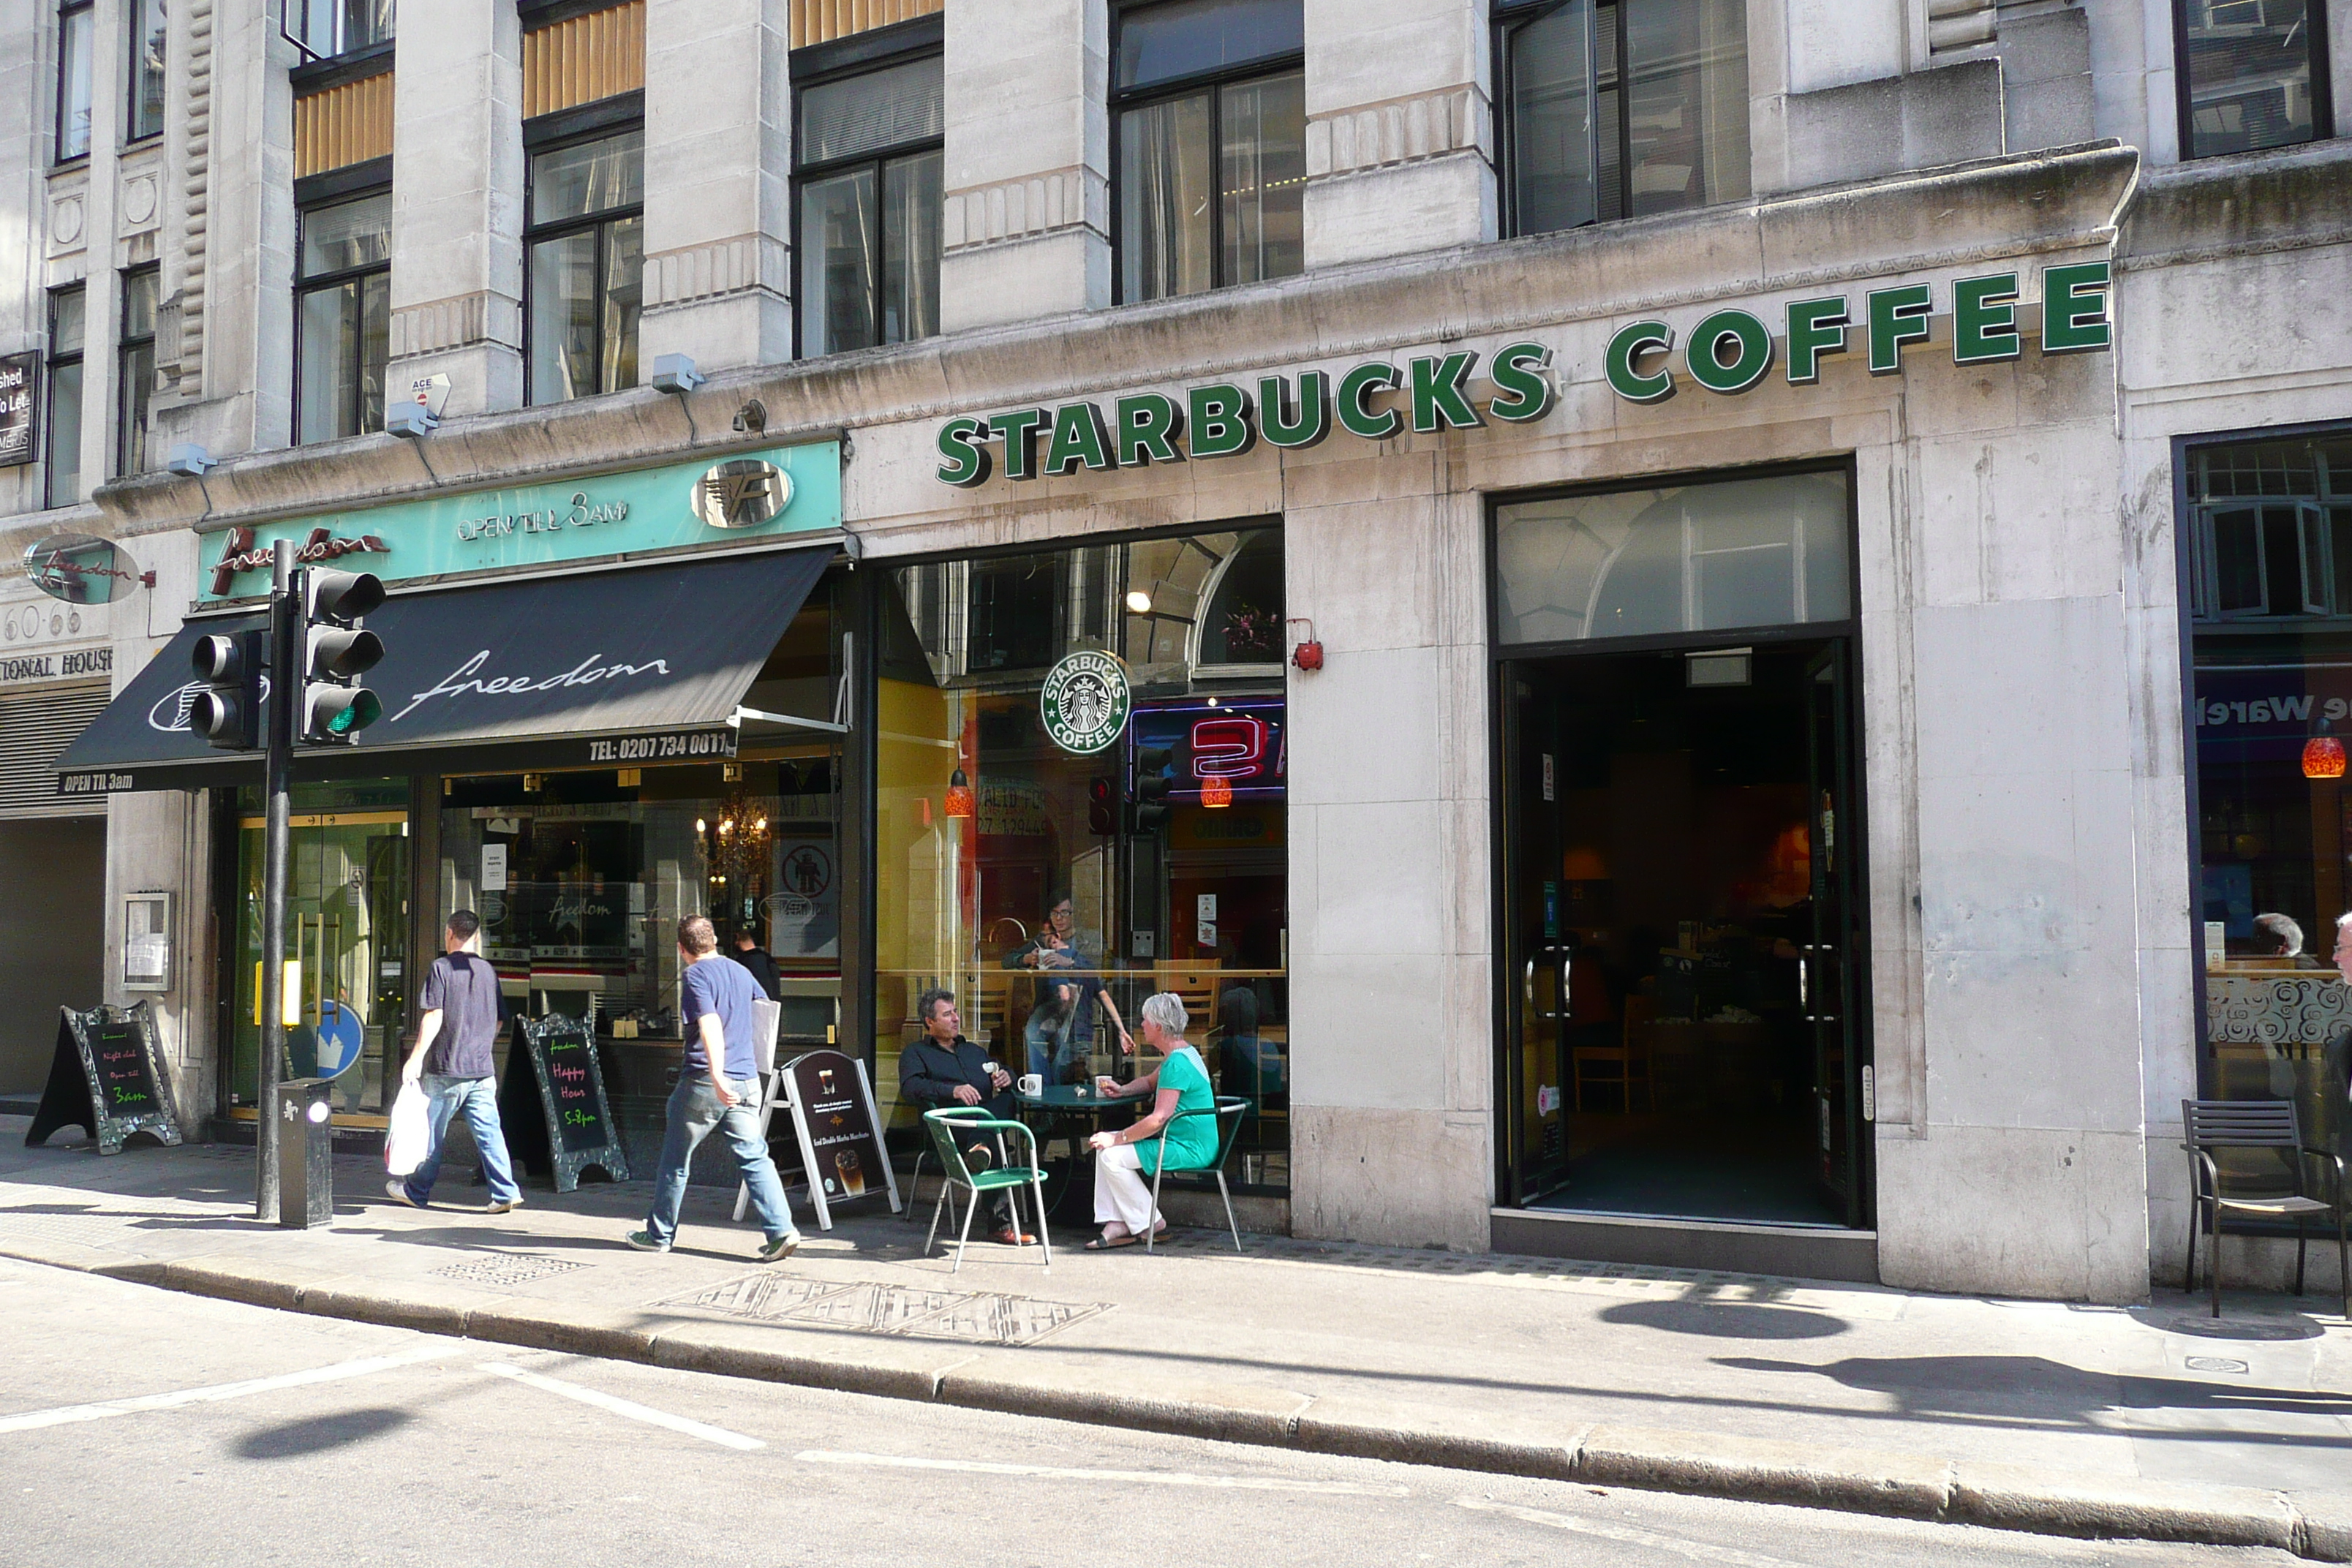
(640, 0), (793, 374)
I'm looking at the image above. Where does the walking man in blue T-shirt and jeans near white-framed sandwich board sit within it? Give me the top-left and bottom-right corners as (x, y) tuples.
(628, 914), (799, 1262)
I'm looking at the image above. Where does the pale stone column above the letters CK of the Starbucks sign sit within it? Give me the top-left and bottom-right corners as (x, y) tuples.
(1305, 0), (1496, 268)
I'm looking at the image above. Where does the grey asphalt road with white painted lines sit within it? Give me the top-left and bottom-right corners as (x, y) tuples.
(0, 1260), (2296, 1568)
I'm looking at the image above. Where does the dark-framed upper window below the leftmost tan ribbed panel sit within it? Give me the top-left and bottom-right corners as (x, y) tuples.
(294, 190), (393, 442)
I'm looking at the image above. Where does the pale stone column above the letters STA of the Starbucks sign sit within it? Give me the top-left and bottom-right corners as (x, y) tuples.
(938, 0), (1110, 331)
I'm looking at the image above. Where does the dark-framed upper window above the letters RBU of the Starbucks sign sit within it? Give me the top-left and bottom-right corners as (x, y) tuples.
(1112, 0), (1308, 301)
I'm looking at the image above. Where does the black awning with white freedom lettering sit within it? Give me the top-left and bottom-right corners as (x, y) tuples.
(56, 550), (832, 794)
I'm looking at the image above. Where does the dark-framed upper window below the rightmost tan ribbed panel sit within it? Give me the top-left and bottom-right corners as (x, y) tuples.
(797, 54), (946, 355)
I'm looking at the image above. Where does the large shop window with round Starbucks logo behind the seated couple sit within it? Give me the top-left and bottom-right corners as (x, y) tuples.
(875, 527), (1289, 1189)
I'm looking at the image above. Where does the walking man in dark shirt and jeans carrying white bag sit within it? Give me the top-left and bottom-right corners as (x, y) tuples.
(383, 910), (522, 1213)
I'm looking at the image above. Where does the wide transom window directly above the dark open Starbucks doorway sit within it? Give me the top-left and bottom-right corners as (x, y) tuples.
(1496, 472), (1851, 642)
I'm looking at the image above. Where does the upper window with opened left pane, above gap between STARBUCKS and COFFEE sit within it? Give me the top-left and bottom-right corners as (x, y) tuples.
(1499, 0), (1747, 235)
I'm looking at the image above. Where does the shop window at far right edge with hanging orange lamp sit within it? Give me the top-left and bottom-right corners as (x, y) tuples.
(2182, 430), (2352, 1175)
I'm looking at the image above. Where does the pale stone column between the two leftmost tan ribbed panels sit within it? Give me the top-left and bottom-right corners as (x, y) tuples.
(388, 0), (524, 414)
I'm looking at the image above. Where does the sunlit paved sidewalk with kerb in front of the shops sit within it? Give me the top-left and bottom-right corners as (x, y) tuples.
(0, 1117), (2352, 1561)
